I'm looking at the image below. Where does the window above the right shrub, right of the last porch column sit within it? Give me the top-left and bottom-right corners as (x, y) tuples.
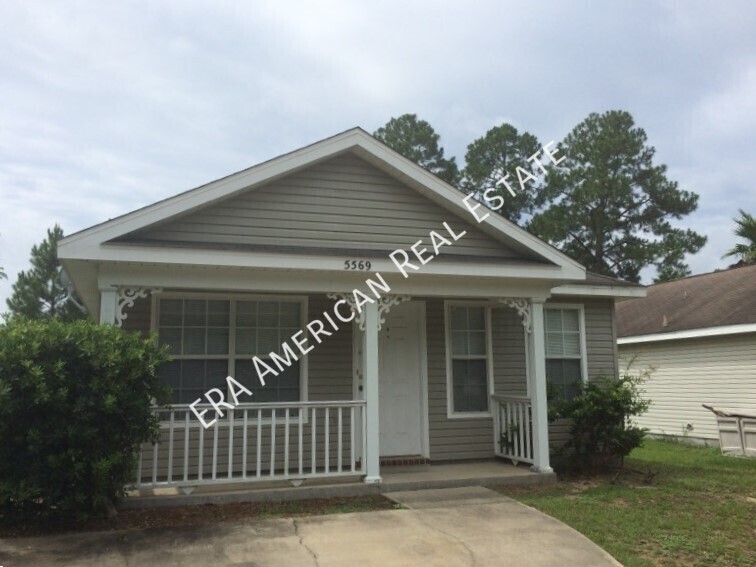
(544, 308), (584, 399)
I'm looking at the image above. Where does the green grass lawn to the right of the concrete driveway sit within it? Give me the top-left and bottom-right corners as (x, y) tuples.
(500, 441), (756, 567)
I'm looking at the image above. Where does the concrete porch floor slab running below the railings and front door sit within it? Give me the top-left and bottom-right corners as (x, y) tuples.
(120, 460), (556, 509)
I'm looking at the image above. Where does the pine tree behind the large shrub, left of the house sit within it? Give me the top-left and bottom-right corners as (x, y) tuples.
(7, 224), (85, 321)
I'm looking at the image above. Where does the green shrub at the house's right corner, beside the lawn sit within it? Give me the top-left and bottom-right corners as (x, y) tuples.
(549, 372), (649, 473)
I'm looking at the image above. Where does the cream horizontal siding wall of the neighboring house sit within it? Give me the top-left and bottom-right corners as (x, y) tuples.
(619, 333), (756, 441)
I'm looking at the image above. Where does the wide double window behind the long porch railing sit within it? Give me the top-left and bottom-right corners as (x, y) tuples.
(158, 298), (303, 404)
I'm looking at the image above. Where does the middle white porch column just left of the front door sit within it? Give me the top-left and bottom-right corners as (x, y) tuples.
(362, 303), (382, 484)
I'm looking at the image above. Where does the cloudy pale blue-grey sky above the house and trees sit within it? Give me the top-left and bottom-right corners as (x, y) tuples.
(0, 0), (756, 311)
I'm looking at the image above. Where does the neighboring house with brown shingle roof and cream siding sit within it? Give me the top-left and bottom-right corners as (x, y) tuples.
(617, 265), (756, 444)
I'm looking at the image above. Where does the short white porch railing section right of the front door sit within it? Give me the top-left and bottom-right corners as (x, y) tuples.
(491, 395), (533, 465)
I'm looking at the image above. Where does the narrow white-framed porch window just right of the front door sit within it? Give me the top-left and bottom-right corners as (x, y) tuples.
(447, 306), (489, 414)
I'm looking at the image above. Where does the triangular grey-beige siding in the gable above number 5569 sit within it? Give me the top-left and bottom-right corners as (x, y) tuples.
(122, 153), (518, 258)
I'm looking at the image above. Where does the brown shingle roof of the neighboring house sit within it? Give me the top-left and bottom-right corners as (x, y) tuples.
(616, 265), (756, 340)
